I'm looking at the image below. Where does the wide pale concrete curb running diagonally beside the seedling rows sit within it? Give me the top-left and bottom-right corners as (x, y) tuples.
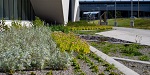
(90, 46), (139, 75)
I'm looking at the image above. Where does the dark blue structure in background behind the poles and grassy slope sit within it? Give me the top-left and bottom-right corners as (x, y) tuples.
(80, 0), (150, 19)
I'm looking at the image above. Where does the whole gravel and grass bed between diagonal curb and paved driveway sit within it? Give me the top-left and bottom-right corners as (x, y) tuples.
(78, 35), (150, 75)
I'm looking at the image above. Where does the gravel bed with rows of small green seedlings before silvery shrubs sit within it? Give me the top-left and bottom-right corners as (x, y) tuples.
(0, 52), (124, 75)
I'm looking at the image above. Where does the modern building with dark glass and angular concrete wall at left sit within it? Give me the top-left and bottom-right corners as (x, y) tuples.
(0, 0), (79, 24)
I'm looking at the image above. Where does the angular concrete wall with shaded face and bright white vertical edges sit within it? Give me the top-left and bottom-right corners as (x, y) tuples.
(30, 0), (79, 24)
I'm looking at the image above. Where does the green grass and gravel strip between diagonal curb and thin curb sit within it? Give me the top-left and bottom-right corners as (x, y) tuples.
(90, 42), (150, 61)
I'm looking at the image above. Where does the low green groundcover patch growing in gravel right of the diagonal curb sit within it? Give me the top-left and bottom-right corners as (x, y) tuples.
(90, 42), (142, 56)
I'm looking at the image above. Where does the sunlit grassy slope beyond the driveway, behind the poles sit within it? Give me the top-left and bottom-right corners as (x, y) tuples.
(92, 18), (150, 29)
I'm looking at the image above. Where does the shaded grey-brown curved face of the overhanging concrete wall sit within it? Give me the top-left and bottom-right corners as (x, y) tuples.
(30, 0), (64, 24)
